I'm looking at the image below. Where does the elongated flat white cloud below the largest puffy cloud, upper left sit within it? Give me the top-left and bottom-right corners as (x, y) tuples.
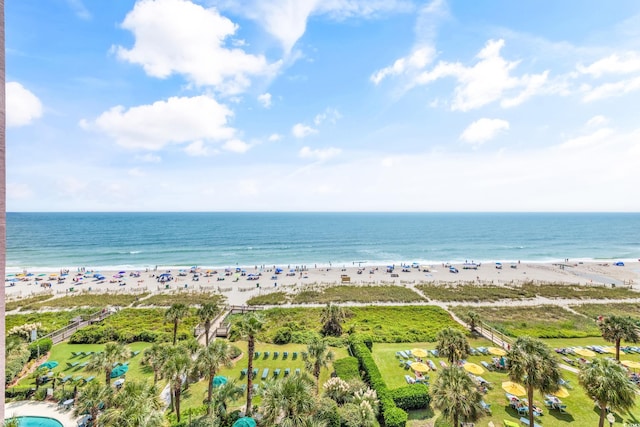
(80, 95), (235, 150)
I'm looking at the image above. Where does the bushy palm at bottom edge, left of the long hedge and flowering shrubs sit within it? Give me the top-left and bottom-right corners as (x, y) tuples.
(261, 374), (315, 427)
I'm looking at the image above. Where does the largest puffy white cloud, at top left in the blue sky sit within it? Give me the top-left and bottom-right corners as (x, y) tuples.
(114, 0), (280, 94)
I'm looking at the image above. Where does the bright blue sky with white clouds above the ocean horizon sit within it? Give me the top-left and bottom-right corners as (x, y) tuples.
(5, 0), (640, 211)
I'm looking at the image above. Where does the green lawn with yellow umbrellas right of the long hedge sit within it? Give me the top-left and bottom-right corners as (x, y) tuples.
(373, 338), (640, 427)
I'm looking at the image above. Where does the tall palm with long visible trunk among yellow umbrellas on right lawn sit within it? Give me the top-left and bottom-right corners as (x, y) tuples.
(508, 337), (561, 425)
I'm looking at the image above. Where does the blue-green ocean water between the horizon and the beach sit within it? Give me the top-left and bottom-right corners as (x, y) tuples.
(7, 212), (640, 271)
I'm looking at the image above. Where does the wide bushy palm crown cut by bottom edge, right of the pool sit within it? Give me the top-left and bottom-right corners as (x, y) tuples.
(101, 381), (164, 427)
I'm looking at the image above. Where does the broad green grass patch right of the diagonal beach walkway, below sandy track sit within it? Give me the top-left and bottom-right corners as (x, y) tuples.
(452, 305), (600, 338)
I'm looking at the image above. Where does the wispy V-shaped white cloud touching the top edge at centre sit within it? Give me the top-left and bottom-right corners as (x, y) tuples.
(219, 0), (413, 55)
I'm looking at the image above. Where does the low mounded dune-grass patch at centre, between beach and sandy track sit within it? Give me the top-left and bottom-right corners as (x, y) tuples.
(290, 285), (424, 304)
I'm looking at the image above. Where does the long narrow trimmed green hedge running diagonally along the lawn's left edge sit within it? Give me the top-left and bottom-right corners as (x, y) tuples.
(350, 335), (408, 427)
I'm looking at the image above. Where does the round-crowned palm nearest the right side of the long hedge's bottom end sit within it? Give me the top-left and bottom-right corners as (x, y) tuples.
(431, 365), (482, 426)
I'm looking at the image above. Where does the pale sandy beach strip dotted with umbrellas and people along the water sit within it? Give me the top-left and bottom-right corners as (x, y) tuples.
(5, 260), (640, 305)
